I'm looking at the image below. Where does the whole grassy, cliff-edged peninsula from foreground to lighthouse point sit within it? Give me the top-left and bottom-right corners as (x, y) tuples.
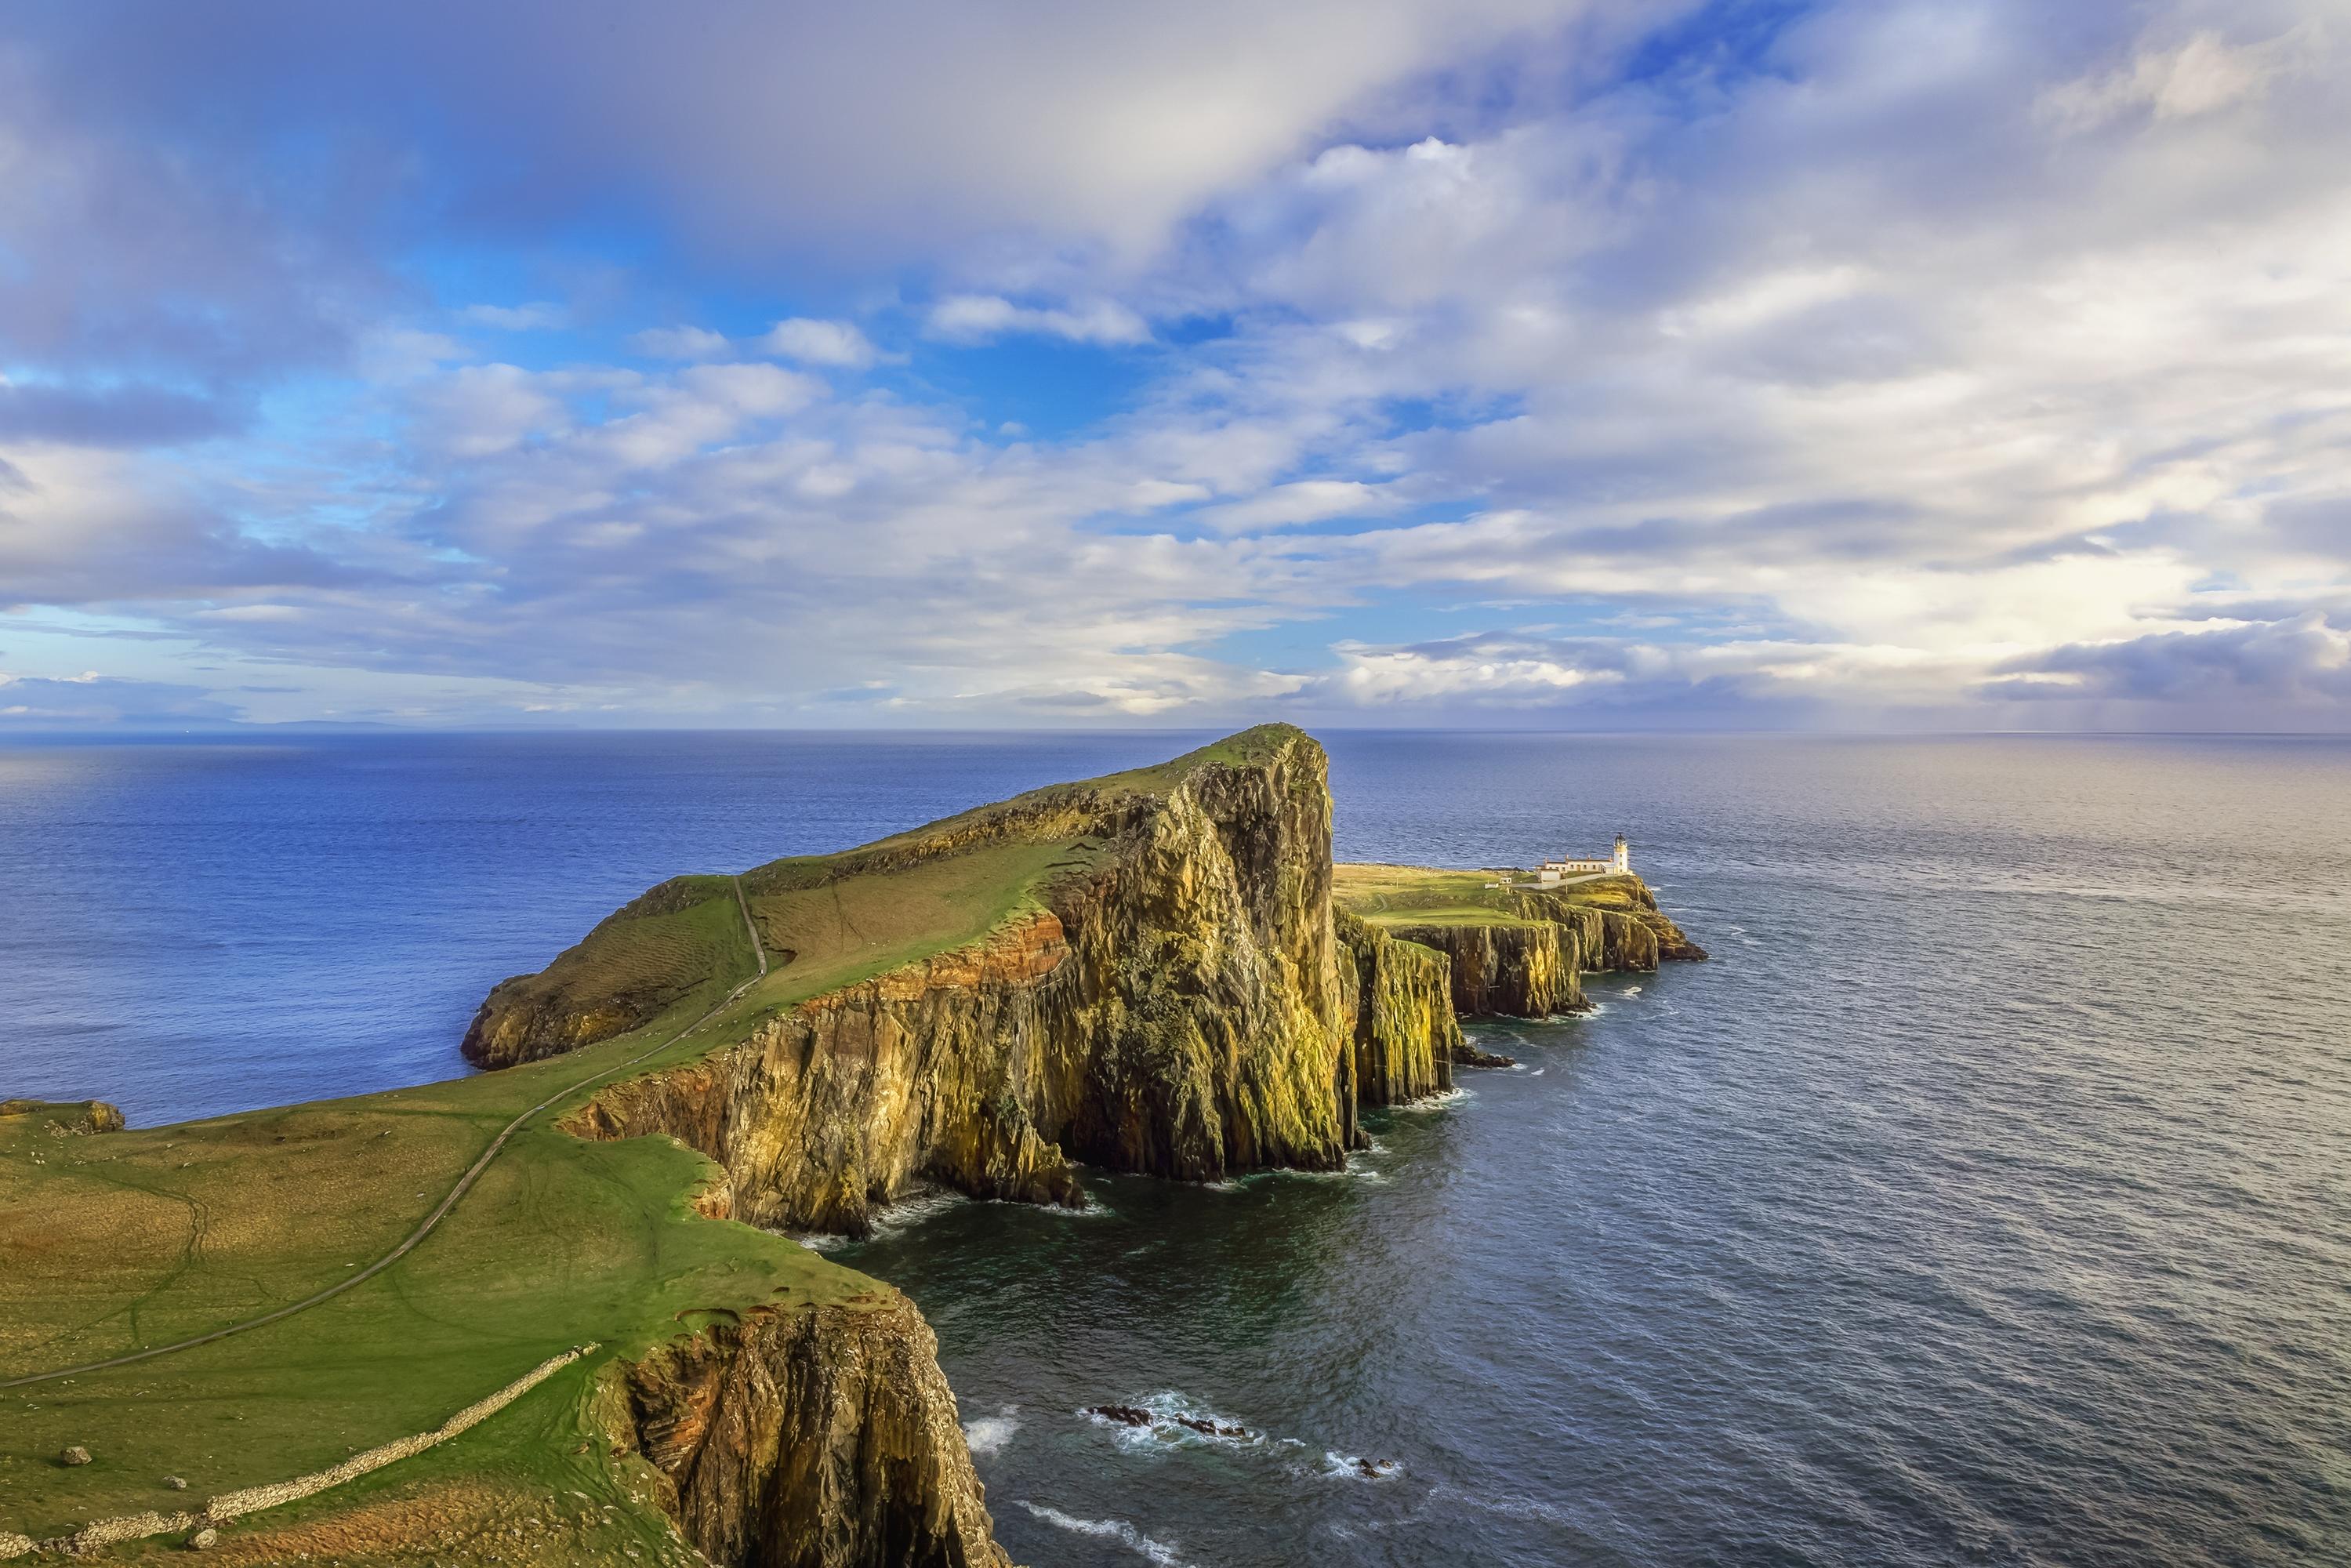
(0, 727), (1702, 1568)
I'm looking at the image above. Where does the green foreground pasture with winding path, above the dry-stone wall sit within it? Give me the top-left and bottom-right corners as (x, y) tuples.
(0, 992), (877, 1537)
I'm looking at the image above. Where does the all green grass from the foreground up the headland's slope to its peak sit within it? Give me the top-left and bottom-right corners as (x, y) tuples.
(0, 731), (1281, 1561)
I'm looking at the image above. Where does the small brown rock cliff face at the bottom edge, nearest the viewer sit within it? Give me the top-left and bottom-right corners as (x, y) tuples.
(626, 1290), (1011, 1568)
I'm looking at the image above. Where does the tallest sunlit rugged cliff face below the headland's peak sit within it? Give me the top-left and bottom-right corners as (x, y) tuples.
(571, 729), (1354, 1232)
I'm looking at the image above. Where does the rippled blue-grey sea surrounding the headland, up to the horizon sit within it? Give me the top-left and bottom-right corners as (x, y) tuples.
(0, 731), (2351, 1568)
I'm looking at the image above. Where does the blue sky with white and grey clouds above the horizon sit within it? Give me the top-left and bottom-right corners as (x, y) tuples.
(0, 0), (2351, 739)
